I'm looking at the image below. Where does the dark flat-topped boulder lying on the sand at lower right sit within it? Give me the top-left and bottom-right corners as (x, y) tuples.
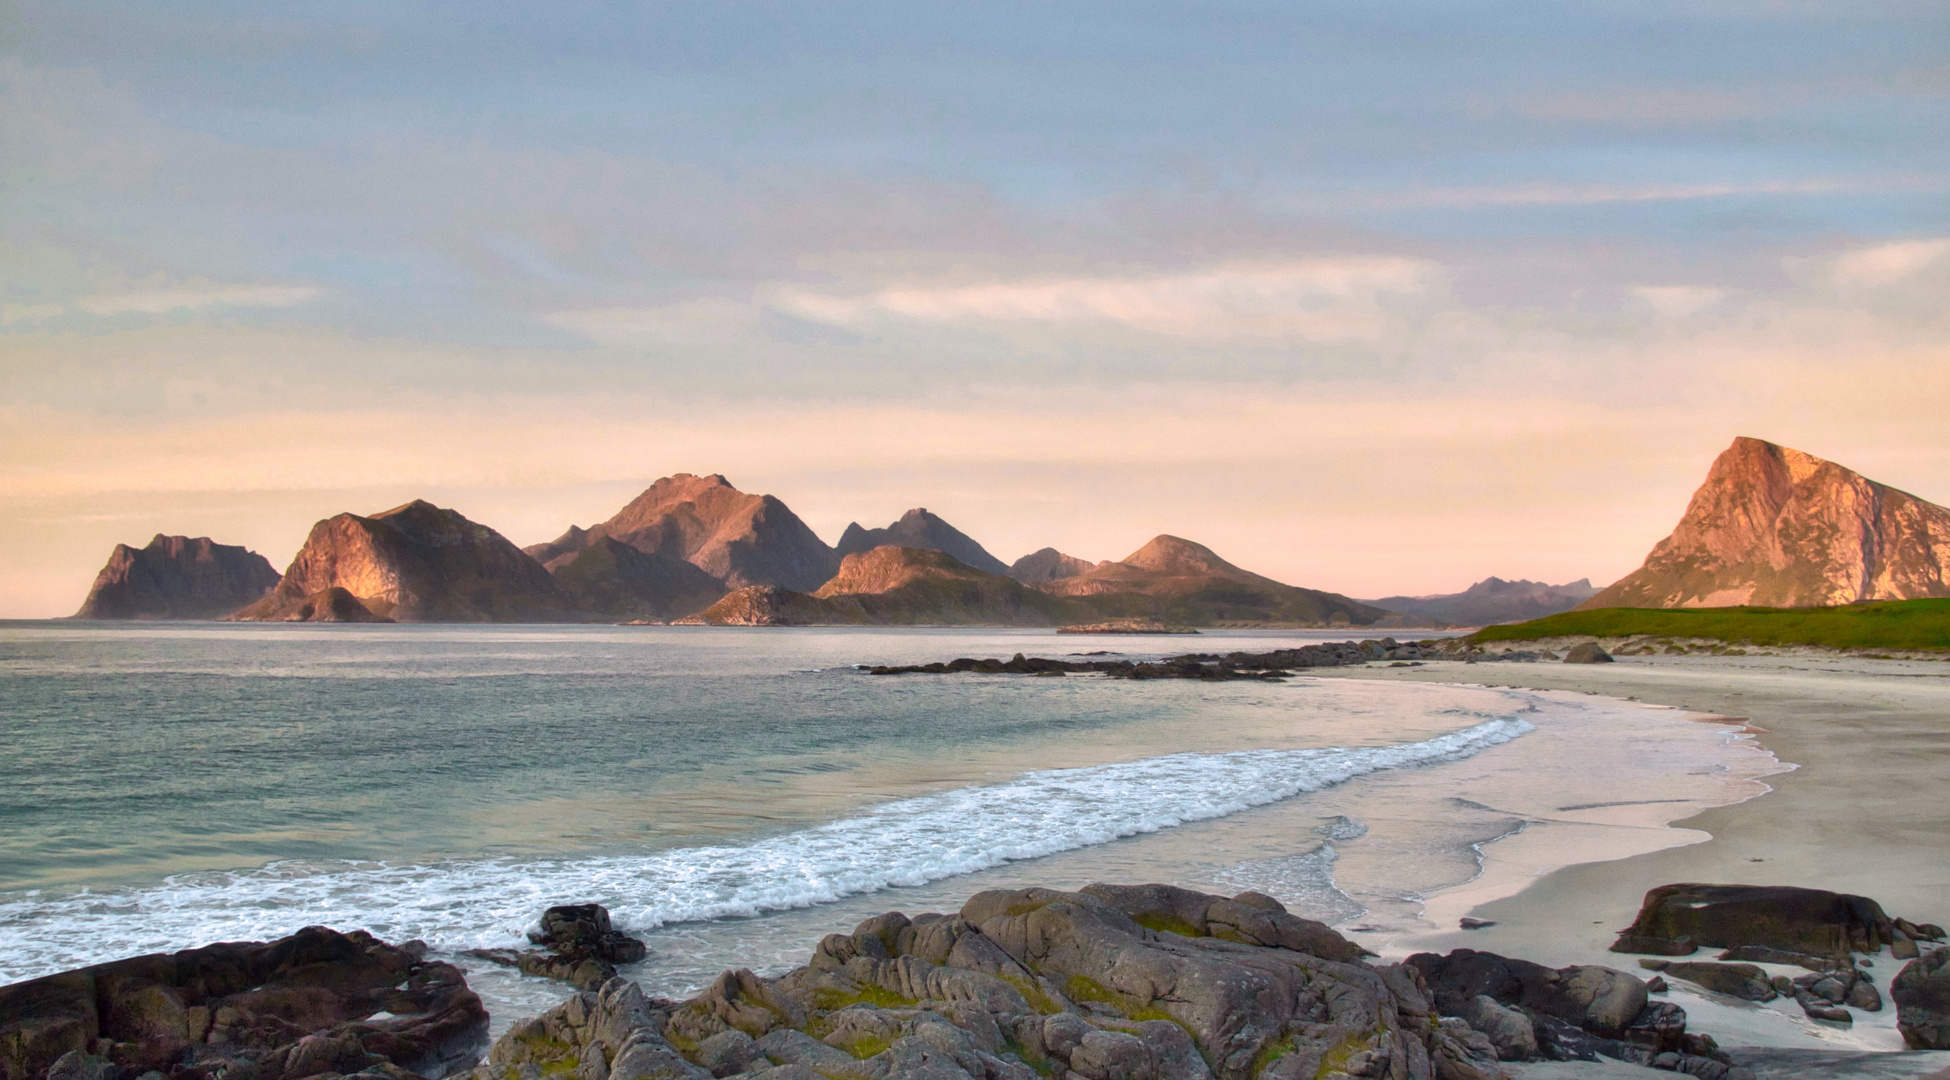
(1611, 885), (1895, 955)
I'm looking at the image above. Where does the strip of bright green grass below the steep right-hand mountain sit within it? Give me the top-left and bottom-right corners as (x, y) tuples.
(1470, 600), (1950, 649)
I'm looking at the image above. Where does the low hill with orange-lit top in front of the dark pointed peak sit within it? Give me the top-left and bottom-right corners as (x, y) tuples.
(698, 544), (1090, 626)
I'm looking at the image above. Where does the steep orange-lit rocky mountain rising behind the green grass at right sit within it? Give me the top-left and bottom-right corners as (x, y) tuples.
(1580, 439), (1950, 610)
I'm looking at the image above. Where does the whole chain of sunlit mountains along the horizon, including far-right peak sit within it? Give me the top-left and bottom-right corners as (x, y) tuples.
(60, 439), (1950, 634)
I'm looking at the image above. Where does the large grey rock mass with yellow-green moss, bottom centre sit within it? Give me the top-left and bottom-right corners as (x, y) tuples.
(476, 885), (1503, 1080)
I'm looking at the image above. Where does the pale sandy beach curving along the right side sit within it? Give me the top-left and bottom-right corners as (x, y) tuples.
(1318, 651), (1950, 1080)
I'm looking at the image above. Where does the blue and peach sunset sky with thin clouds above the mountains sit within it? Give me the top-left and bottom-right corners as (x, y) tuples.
(0, 0), (1950, 618)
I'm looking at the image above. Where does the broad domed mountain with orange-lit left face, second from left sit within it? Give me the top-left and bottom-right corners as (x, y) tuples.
(230, 499), (583, 622)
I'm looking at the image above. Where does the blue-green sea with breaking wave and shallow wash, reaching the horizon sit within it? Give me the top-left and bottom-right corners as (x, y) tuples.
(0, 622), (1780, 1031)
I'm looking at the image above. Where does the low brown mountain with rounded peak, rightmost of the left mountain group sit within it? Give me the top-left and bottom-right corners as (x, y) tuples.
(1035, 536), (1388, 626)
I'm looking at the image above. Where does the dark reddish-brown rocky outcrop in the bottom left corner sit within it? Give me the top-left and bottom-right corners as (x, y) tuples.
(0, 926), (488, 1080)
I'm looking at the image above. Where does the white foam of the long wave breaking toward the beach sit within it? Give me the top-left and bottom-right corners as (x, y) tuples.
(0, 715), (1533, 983)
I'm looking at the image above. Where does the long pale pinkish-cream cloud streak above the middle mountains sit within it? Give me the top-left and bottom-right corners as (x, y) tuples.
(778, 255), (1441, 341)
